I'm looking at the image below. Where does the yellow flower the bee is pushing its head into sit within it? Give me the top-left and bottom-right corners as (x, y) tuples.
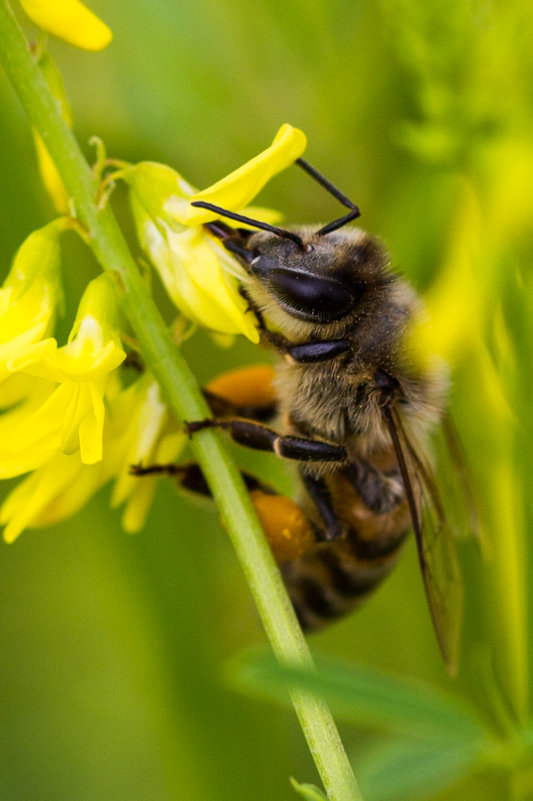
(124, 125), (306, 342)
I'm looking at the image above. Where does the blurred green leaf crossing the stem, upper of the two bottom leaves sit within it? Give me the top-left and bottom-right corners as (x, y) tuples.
(229, 651), (487, 748)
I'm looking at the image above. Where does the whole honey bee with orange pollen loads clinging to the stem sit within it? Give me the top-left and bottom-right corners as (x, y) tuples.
(135, 159), (461, 673)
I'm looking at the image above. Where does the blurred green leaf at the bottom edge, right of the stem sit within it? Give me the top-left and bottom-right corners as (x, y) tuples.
(353, 738), (477, 801)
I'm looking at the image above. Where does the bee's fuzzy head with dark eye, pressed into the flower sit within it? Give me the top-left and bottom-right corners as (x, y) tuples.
(193, 197), (387, 336)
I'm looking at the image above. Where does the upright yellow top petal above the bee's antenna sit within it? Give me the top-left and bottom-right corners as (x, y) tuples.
(165, 124), (307, 225)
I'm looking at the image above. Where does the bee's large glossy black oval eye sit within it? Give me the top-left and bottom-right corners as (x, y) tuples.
(268, 267), (354, 323)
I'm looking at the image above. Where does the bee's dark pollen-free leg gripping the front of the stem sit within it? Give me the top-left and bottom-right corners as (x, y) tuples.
(185, 417), (347, 463)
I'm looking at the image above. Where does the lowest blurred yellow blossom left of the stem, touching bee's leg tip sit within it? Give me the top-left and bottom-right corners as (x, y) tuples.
(0, 373), (186, 542)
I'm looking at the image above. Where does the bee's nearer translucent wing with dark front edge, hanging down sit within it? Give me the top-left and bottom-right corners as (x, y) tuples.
(383, 406), (463, 675)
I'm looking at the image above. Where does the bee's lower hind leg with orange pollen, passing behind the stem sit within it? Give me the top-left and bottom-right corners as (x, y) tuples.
(131, 462), (318, 564)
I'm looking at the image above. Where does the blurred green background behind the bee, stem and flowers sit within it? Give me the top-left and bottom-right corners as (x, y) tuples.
(0, 0), (533, 801)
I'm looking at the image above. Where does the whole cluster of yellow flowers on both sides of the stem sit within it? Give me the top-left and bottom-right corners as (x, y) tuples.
(0, 109), (306, 541)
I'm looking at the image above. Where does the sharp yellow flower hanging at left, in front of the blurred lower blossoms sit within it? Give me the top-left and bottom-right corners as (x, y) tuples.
(0, 275), (126, 478)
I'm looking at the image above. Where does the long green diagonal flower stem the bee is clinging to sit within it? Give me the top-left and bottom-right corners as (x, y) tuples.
(0, 0), (362, 801)
